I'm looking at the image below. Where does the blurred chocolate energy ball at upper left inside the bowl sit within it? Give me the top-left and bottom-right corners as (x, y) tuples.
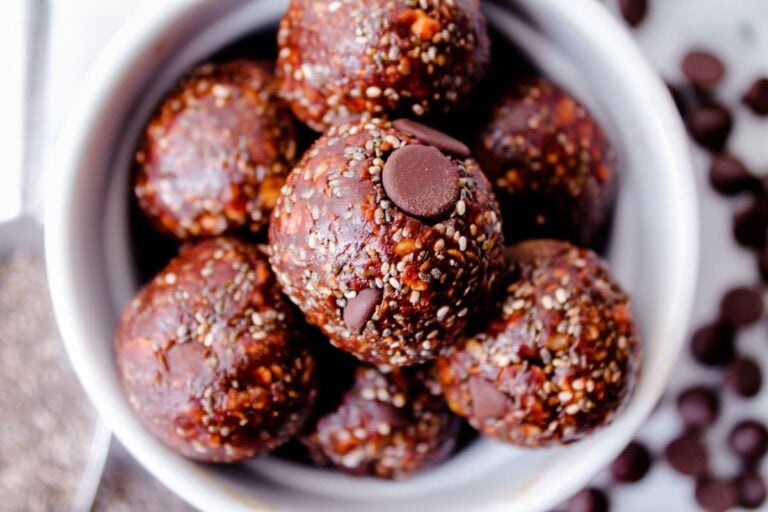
(134, 60), (296, 240)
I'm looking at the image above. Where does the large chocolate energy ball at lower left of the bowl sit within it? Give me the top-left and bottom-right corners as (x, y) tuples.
(115, 238), (316, 462)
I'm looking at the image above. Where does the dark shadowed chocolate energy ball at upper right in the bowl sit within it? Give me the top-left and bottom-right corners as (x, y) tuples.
(475, 78), (617, 246)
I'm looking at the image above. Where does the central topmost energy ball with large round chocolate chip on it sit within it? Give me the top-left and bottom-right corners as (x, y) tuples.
(269, 119), (505, 366)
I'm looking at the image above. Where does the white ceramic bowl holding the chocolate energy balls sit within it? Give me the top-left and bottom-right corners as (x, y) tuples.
(46, 0), (698, 512)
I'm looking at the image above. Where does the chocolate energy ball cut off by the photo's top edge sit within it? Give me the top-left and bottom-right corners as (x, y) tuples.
(277, 0), (490, 131)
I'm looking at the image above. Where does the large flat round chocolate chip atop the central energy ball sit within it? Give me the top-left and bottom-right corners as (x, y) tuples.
(382, 144), (461, 219)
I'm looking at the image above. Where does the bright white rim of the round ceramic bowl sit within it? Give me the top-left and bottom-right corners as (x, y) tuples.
(45, 0), (699, 510)
